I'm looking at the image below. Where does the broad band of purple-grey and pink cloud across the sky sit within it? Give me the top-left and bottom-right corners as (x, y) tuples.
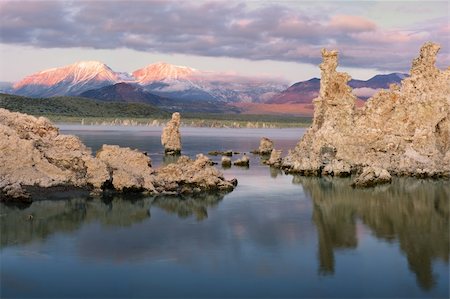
(0, 1), (450, 70)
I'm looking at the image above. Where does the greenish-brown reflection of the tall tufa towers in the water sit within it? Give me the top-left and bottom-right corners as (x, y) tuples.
(293, 176), (450, 289)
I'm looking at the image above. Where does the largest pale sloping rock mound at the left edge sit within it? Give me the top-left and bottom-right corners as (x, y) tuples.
(0, 109), (109, 200)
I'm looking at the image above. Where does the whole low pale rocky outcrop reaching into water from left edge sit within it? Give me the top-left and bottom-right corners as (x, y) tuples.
(0, 109), (235, 201)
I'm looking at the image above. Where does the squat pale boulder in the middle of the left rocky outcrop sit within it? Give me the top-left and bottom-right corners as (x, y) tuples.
(96, 145), (155, 191)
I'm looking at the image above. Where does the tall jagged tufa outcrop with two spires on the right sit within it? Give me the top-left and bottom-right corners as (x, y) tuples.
(283, 43), (450, 177)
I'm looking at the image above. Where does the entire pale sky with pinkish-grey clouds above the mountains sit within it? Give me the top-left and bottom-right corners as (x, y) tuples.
(0, 0), (450, 83)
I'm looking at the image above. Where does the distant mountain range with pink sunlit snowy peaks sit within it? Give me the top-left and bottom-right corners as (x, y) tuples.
(0, 61), (407, 115)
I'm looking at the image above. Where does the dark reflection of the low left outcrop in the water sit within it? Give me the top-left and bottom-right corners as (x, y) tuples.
(0, 193), (224, 248)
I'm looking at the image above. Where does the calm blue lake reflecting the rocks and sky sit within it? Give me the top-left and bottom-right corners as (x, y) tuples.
(0, 125), (450, 298)
